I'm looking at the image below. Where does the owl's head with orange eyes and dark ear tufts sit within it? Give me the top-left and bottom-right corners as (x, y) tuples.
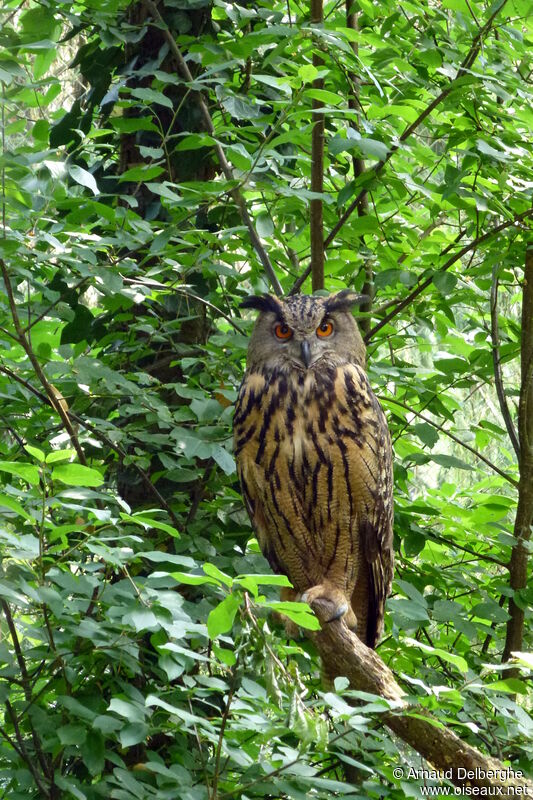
(241, 289), (366, 371)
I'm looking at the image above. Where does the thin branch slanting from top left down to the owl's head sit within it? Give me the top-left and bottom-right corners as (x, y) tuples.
(143, 0), (283, 296)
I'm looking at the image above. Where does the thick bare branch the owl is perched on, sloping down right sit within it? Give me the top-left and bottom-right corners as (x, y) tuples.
(309, 601), (533, 797)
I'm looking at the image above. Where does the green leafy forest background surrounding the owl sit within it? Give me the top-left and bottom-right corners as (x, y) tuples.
(0, 0), (533, 800)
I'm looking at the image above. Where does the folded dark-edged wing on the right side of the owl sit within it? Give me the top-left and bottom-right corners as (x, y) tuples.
(339, 365), (394, 647)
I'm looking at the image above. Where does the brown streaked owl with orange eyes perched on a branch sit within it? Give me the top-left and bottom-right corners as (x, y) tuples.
(234, 290), (393, 647)
